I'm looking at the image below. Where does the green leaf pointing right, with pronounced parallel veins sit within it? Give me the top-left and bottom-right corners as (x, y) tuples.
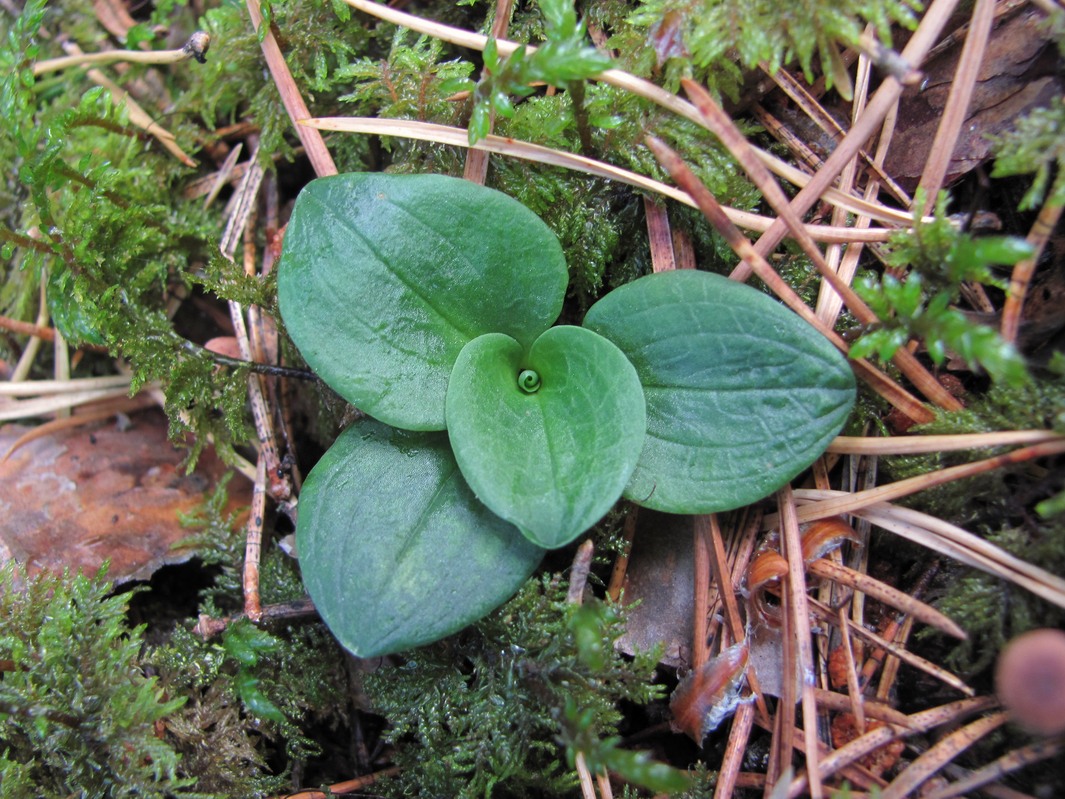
(584, 271), (855, 513)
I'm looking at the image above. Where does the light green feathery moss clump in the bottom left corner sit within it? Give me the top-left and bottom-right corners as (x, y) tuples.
(0, 566), (195, 799)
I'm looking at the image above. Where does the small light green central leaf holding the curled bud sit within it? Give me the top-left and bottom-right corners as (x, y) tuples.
(447, 326), (646, 548)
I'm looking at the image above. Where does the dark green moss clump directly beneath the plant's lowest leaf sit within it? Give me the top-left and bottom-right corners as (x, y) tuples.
(365, 577), (659, 797)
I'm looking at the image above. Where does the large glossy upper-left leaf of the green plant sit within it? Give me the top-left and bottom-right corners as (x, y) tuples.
(278, 174), (569, 430)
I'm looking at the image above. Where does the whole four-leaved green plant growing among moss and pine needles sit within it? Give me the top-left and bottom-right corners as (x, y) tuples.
(278, 174), (855, 657)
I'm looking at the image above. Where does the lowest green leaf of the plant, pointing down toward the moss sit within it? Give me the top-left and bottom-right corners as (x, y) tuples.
(296, 420), (543, 657)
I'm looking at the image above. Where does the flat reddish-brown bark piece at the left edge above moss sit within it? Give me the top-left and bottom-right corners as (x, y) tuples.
(0, 411), (251, 583)
